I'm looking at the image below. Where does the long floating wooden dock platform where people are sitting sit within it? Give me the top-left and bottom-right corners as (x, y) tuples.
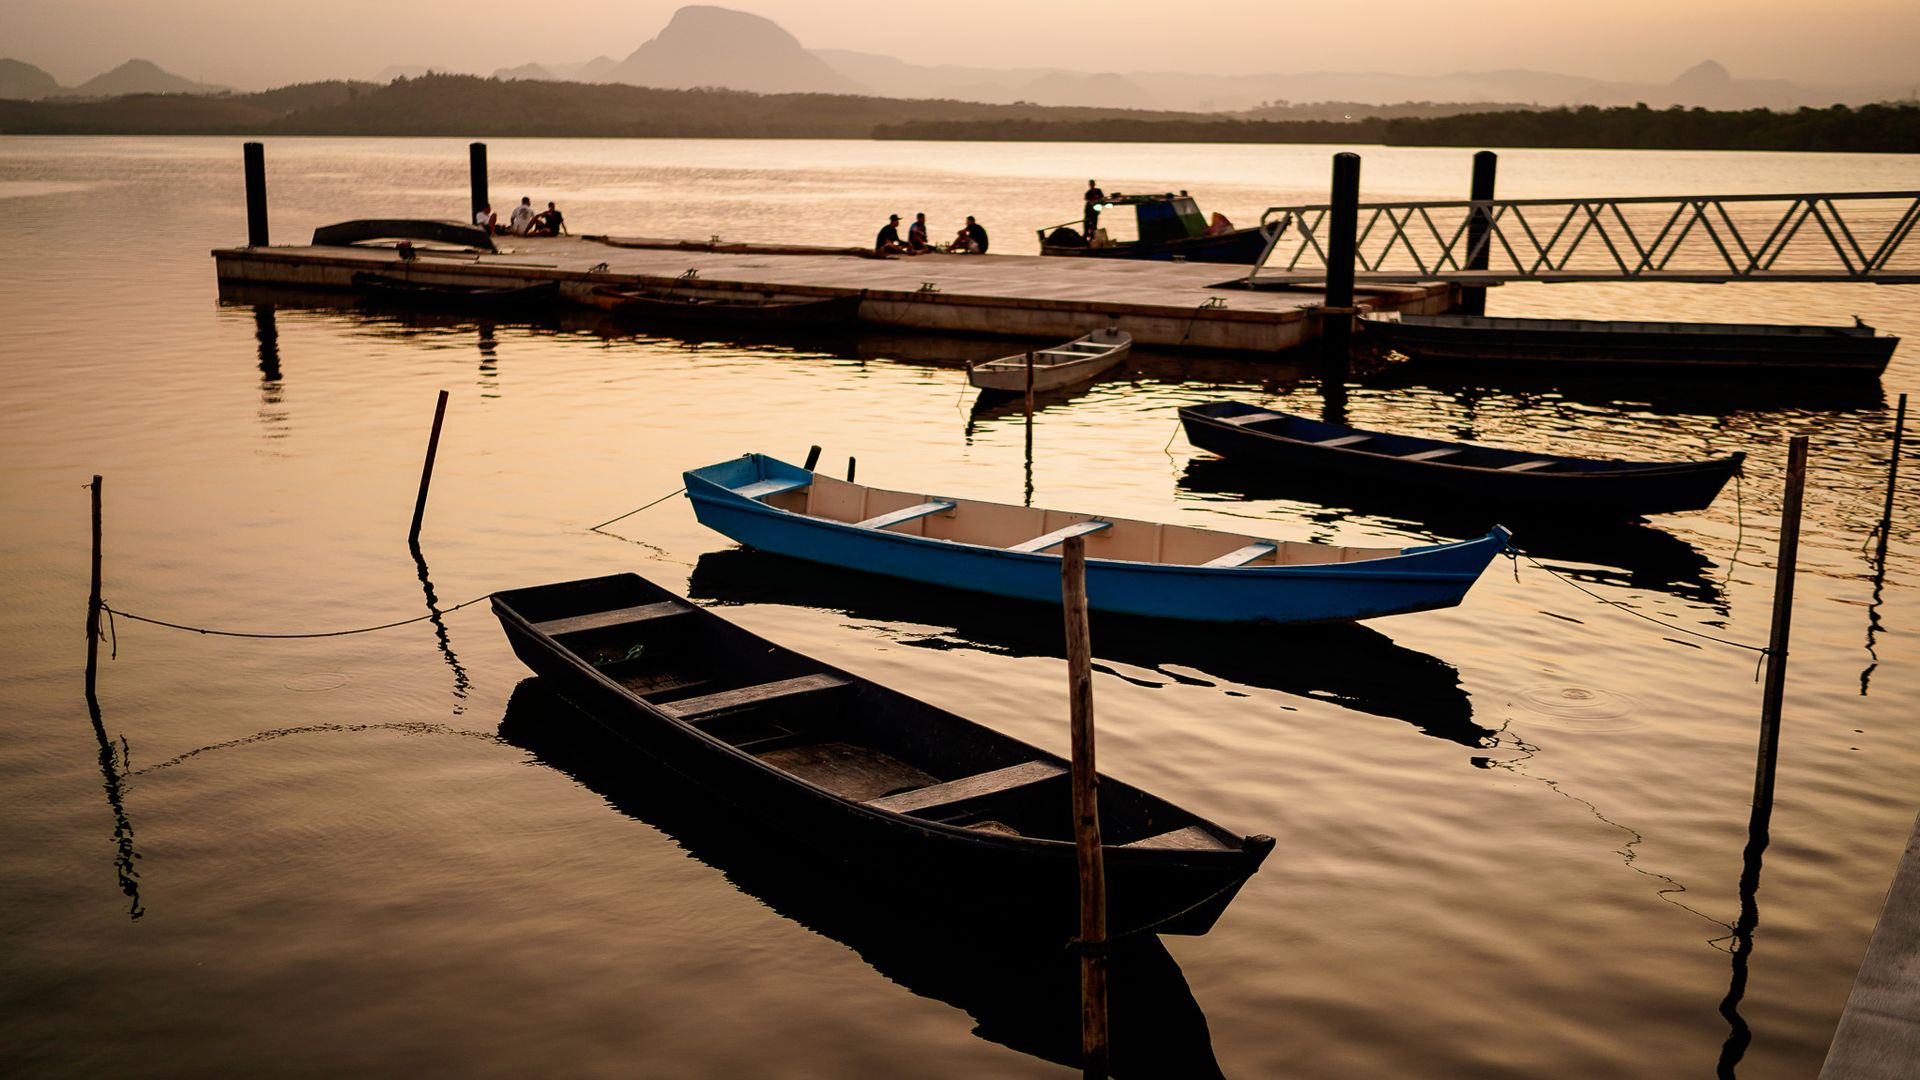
(213, 236), (1455, 354)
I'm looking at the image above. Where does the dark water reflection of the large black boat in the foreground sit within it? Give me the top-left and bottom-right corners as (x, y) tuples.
(499, 678), (1221, 1078)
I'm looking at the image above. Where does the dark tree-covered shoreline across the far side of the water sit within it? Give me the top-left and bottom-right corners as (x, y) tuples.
(0, 75), (1920, 154)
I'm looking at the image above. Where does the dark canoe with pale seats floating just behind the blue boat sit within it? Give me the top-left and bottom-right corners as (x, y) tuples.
(1181, 402), (1745, 517)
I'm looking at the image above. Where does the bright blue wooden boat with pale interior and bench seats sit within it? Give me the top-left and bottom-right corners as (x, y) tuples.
(685, 454), (1507, 623)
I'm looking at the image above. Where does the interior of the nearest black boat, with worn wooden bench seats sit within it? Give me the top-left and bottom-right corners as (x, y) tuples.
(495, 575), (1242, 851)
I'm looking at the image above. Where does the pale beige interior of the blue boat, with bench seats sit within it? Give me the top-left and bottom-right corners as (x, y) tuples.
(762, 473), (1404, 567)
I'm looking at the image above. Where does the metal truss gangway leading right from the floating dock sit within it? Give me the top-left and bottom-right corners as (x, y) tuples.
(1246, 190), (1920, 286)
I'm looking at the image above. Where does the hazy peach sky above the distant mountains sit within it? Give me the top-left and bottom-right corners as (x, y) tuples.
(15, 0), (1920, 88)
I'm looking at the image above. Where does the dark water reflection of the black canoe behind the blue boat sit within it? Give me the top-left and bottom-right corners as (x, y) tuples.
(1179, 457), (1724, 609)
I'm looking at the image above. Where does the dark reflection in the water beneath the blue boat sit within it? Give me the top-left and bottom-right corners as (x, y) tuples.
(687, 548), (1498, 748)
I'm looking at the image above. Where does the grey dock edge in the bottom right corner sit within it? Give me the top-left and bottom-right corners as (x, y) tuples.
(1820, 821), (1920, 1080)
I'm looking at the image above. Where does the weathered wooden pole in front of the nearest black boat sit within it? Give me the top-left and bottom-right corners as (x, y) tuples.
(1060, 536), (1108, 1078)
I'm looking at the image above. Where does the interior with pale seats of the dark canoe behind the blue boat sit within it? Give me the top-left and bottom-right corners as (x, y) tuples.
(1183, 402), (1711, 477)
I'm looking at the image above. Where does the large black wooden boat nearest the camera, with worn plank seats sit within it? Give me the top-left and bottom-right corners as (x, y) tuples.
(493, 575), (1273, 936)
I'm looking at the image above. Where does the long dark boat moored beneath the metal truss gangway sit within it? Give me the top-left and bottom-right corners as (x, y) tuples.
(1359, 315), (1899, 379)
